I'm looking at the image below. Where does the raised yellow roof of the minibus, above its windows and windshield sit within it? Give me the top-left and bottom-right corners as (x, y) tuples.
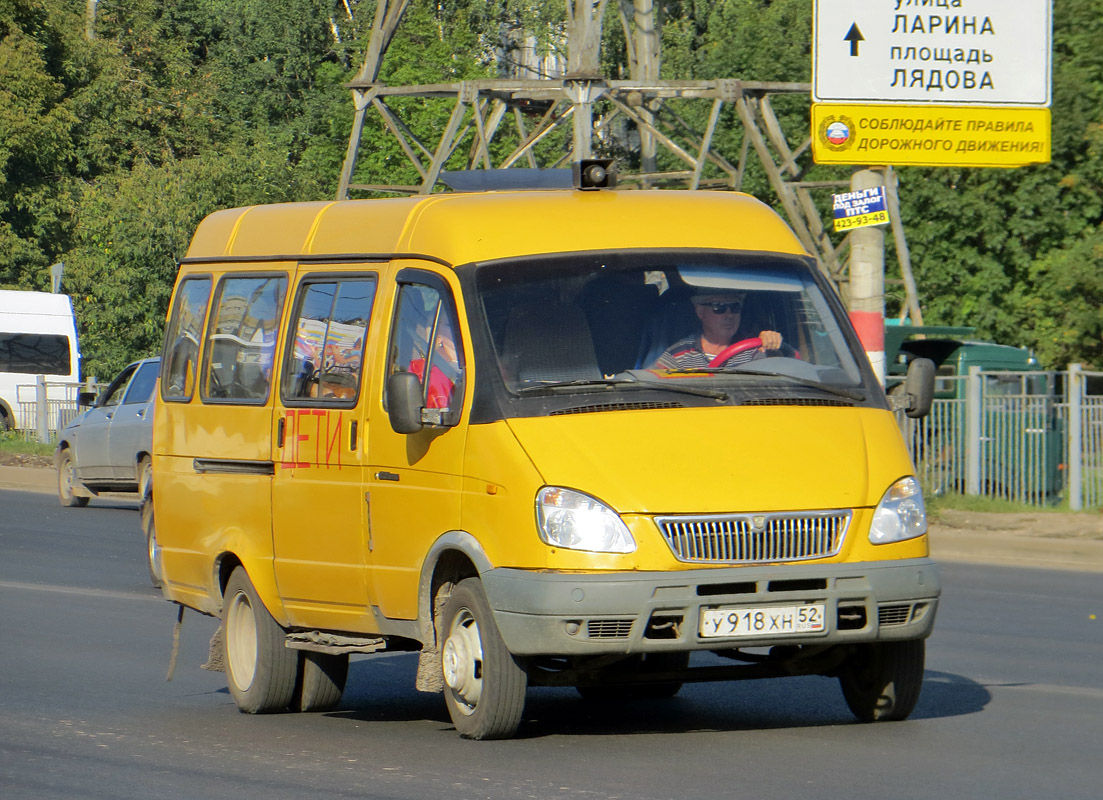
(178, 190), (807, 265)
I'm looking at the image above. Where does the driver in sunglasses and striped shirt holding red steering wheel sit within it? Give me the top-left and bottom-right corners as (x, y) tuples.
(653, 289), (781, 370)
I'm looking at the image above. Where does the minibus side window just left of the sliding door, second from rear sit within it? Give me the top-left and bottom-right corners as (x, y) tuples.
(203, 275), (287, 405)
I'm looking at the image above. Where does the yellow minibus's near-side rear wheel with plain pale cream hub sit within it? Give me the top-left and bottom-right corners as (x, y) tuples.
(222, 567), (299, 714)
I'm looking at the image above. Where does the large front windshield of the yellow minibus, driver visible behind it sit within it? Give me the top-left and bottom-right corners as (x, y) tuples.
(475, 250), (866, 402)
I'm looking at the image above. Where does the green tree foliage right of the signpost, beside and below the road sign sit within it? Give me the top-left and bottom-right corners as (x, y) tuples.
(900, 0), (1103, 367)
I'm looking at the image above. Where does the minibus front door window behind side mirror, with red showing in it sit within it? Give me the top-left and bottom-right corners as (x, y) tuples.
(387, 284), (463, 412)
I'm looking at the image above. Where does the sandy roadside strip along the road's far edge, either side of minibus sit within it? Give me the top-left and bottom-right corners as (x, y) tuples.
(0, 467), (1103, 573)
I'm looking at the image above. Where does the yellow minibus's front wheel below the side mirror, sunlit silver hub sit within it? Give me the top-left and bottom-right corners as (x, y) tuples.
(439, 578), (528, 739)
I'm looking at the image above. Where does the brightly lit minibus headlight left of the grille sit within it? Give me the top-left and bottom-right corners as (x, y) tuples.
(536, 487), (635, 553)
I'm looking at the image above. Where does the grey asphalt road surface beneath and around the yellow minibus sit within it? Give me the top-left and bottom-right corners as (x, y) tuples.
(0, 490), (1103, 800)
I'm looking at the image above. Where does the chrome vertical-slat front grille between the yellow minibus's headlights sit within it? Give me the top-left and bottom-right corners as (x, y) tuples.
(655, 510), (850, 564)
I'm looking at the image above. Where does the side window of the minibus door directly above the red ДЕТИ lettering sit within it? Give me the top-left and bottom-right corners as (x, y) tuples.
(280, 278), (375, 405)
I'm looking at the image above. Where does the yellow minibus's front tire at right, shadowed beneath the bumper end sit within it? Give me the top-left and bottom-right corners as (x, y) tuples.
(838, 639), (927, 723)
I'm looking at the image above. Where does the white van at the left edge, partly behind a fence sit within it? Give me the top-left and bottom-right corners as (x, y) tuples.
(0, 289), (81, 430)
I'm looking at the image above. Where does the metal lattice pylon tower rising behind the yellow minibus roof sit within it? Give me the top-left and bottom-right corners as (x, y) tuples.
(338, 0), (921, 320)
